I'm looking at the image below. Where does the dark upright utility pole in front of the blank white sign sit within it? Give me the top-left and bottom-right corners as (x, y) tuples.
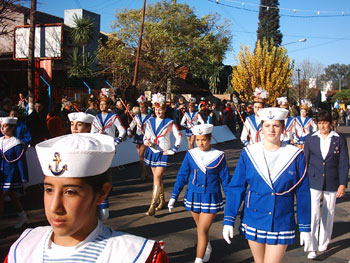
(28, 0), (36, 114)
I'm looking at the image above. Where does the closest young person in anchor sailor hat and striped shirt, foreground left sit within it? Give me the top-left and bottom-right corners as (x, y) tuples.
(5, 133), (168, 263)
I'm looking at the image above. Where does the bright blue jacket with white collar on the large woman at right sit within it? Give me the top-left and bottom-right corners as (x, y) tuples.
(224, 143), (311, 232)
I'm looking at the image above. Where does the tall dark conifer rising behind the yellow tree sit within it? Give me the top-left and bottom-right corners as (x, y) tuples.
(257, 0), (282, 46)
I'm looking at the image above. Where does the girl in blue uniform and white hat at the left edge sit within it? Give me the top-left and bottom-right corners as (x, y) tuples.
(0, 117), (29, 229)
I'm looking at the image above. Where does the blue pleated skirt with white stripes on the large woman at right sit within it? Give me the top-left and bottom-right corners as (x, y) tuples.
(240, 223), (295, 245)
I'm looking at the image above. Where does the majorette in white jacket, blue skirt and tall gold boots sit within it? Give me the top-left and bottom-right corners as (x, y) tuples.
(143, 93), (181, 216)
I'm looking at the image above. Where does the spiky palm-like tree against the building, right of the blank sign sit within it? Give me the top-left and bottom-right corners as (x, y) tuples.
(70, 15), (94, 66)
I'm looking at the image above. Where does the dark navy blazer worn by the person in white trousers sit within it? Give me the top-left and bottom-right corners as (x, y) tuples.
(304, 132), (349, 191)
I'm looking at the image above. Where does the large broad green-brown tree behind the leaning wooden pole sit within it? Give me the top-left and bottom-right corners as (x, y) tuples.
(98, 1), (231, 94)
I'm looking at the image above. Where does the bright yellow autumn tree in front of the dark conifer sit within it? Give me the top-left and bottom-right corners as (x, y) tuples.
(231, 40), (294, 104)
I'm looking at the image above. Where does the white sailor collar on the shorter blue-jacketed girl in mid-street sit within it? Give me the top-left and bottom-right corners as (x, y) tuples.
(188, 147), (224, 173)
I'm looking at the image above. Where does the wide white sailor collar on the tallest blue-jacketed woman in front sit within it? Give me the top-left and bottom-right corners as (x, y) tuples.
(244, 142), (302, 189)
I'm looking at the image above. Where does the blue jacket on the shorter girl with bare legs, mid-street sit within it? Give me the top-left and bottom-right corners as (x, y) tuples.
(171, 148), (230, 199)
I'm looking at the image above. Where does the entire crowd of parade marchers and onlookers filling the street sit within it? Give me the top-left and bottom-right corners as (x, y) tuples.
(0, 88), (349, 263)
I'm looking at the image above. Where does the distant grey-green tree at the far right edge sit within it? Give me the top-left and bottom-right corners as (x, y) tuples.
(321, 64), (350, 89)
